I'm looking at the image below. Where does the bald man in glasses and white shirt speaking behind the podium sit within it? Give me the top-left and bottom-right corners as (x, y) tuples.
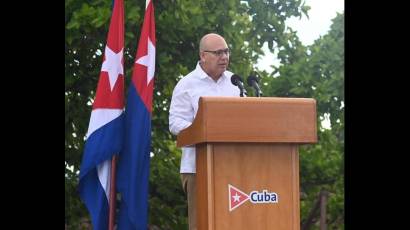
(169, 33), (240, 230)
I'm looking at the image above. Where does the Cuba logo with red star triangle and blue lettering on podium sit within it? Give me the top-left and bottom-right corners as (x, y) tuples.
(228, 184), (279, 212)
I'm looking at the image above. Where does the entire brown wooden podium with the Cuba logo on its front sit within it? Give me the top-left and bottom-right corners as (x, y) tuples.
(177, 97), (317, 230)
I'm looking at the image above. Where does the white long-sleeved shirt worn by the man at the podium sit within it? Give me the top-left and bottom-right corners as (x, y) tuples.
(169, 62), (240, 173)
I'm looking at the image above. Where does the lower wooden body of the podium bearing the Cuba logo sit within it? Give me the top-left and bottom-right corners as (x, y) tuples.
(197, 143), (300, 230)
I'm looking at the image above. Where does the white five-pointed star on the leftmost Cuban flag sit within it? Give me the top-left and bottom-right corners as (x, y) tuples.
(101, 46), (124, 91)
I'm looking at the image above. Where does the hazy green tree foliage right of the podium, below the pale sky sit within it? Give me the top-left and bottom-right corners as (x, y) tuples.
(262, 14), (344, 229)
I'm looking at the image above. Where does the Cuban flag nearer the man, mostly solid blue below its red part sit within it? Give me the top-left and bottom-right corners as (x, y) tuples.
(117, 0), (155, 230)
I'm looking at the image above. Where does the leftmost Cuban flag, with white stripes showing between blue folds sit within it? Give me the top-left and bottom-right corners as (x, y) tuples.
(79, 0), (124, 230)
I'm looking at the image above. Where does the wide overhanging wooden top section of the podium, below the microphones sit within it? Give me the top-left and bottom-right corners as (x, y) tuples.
(177, 97), (317, 147)
